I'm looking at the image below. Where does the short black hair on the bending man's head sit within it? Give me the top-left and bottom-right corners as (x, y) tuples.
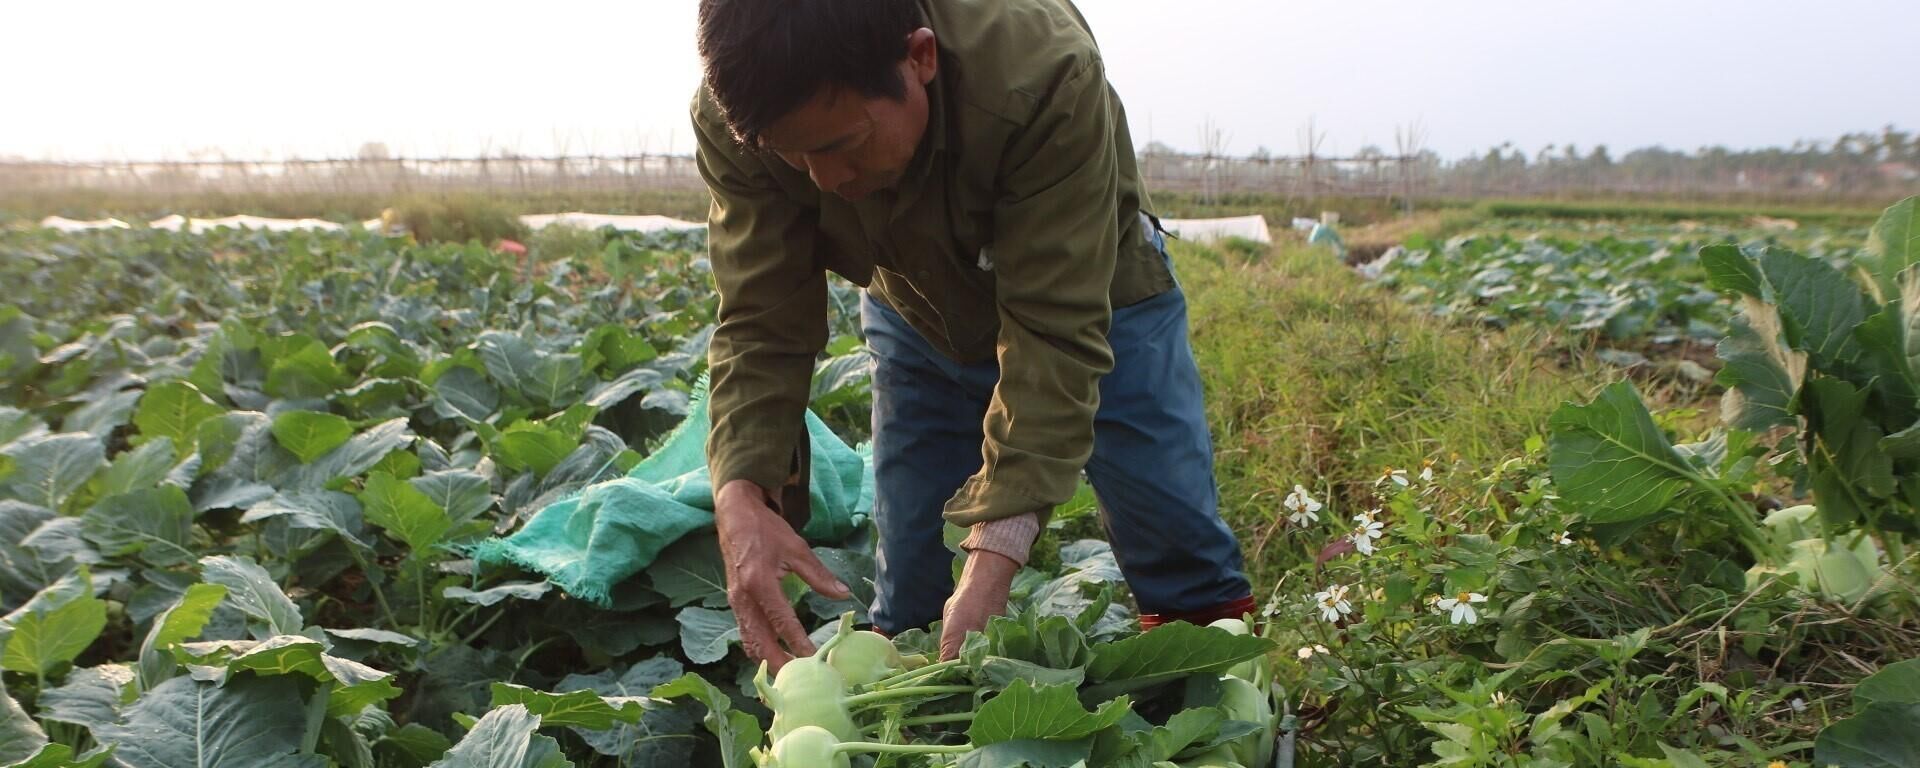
(699, 0), (924, 146)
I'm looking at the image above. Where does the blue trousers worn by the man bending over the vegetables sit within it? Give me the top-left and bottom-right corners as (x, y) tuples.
(860, 249), (1250, 634)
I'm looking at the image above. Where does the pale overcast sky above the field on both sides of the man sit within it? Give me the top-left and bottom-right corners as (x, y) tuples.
(0, 0), (1920, 159)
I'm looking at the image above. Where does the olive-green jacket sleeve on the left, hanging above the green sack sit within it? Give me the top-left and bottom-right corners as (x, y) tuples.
(693, 88), (828, 522)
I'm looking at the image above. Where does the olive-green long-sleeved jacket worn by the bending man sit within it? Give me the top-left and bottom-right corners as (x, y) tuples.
(693, 0), (1173, 526)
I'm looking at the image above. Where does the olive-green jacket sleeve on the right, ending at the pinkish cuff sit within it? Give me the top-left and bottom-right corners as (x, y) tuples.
(945, 56), (1133, 526)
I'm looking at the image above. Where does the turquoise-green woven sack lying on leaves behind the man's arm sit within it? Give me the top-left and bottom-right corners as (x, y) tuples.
(468, 376), (874, 607)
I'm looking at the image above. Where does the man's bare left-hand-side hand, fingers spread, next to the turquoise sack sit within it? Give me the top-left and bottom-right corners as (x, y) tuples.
(714, 480), (852, 672)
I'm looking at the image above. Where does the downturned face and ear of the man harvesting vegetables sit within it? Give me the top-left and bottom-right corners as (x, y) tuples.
(760, 29), (939, 200)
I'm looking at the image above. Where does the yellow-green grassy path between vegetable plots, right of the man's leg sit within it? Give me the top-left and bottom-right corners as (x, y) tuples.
(1177, 237), (1609, 584)
